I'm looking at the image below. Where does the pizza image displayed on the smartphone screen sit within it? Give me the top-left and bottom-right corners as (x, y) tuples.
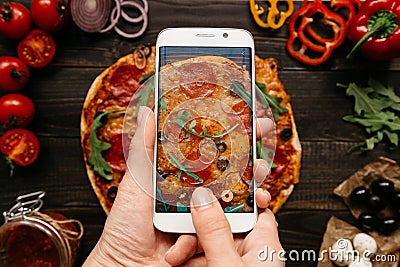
(155, 56), (254, 212)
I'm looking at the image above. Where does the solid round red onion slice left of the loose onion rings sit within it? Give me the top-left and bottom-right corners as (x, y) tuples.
(70, 0), (111, 32)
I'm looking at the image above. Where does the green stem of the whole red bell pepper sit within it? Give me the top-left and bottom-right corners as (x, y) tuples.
(346, 10), (398, 60)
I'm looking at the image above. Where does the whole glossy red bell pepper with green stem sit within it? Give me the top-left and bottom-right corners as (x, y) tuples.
(347, 0), (400, 60)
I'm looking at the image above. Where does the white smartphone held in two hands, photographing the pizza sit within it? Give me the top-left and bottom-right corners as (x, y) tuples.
(153, 28), (257, 233)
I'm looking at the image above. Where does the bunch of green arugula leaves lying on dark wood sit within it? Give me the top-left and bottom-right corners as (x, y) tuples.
(337, 78), (400, 151)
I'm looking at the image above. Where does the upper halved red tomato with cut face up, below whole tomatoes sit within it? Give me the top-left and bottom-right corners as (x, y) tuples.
(18, 29), (56, 68)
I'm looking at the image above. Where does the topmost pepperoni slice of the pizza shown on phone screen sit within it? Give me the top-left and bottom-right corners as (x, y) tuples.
(178, 62), (217, 98)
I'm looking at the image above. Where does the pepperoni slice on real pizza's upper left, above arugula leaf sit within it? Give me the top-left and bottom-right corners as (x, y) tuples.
(110, 63), (144, 103)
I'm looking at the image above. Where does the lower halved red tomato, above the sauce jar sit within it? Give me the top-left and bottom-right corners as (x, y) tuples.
(0, 129), (39, 166)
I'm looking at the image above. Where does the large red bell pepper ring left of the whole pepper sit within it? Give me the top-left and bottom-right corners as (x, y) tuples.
(286, 0), (346, 65)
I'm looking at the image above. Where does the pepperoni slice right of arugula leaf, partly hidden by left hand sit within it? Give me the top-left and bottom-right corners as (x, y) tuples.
(103, 134), (126, 172)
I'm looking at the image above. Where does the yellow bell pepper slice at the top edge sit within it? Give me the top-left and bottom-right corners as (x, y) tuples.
(249, 0), (294, 30)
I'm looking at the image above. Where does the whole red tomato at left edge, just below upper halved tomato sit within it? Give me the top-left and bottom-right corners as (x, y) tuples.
(0, 56), (29, 92)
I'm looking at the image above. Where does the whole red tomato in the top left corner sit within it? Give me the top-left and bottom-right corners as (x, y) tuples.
(0, 2), (32, 40)
